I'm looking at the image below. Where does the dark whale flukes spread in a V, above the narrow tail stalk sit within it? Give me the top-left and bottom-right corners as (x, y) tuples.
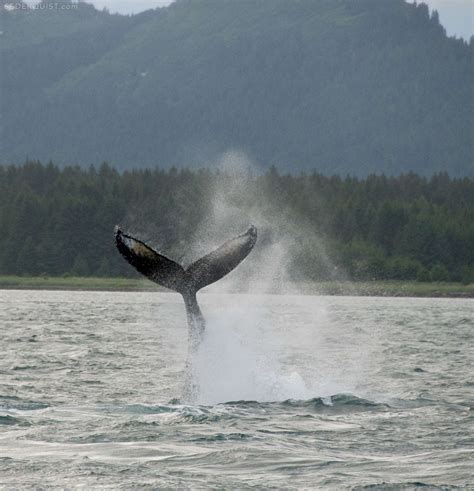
(114, 226), (257, 299)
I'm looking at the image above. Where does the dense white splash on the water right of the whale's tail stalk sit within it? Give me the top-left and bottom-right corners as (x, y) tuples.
(189, 302), (311, 405)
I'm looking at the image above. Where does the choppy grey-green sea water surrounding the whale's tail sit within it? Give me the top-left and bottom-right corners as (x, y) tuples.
(0, 291), (474, 490)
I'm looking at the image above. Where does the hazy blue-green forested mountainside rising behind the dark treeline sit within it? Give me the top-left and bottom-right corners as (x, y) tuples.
(0, 0), (474, 176)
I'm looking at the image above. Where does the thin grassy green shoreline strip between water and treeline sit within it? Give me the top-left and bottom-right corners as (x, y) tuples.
(0, 276), (474, 298)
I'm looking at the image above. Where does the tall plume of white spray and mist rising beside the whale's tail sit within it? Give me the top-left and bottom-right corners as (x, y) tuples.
(179, 152), (360, 404)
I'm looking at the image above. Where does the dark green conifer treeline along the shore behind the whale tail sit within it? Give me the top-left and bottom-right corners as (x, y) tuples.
(0, 162), (474, 282)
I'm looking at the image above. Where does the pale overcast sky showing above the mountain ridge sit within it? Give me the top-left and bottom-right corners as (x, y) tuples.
(30, 0), (474, 40)
